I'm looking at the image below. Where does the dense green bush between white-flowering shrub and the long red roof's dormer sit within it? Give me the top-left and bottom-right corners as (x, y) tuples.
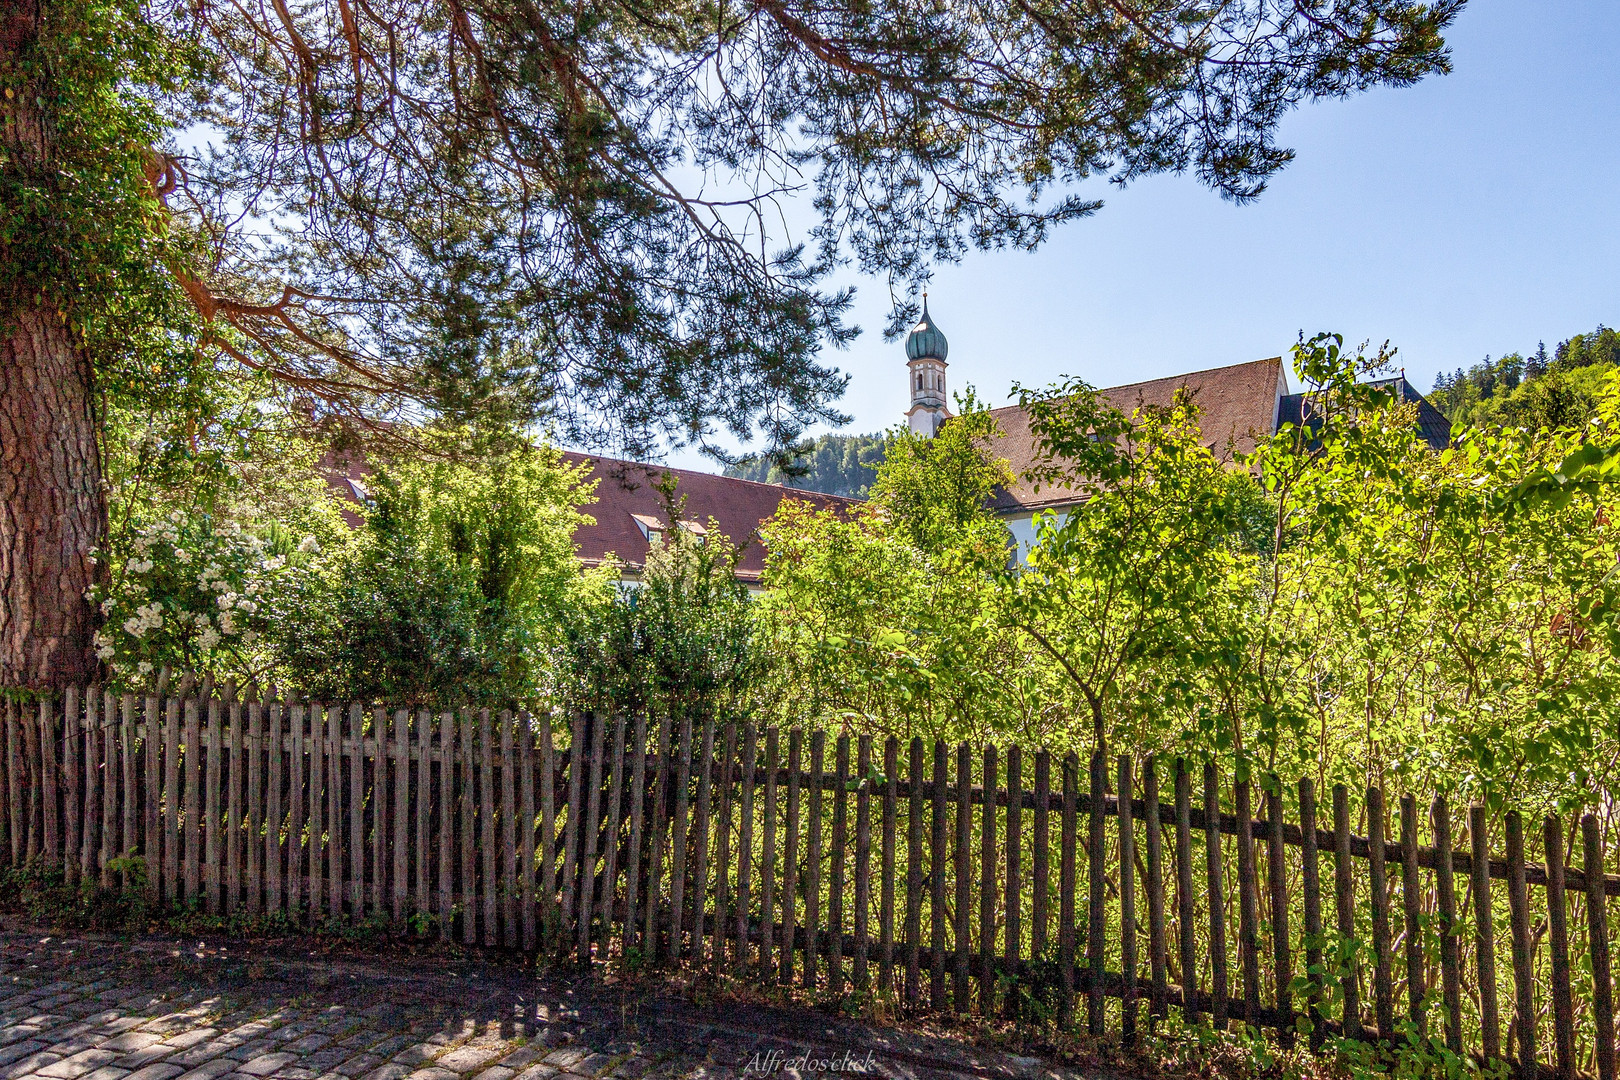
(269, 449), (608, 706)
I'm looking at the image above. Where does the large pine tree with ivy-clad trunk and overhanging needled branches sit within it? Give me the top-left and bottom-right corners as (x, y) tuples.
(0, 0), (1463, 685)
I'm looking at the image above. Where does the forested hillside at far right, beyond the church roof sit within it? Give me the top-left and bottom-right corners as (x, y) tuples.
(1429, 324), (1620, 431)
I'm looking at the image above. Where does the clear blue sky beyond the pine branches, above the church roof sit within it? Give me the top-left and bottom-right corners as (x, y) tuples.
(669, 0), (1620, 470)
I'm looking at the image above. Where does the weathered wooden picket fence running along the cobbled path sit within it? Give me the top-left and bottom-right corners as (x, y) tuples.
(0, 688), (1620, 1080)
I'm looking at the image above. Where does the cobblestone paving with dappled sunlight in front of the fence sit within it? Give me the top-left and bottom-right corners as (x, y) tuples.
(0, 931), (1081, 1080)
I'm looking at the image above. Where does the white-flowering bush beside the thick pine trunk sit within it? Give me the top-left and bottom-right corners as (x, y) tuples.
(91, 512), (319, 685)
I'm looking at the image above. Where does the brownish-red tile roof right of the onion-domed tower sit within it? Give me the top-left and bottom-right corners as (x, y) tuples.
(990, 356), (1288, 513)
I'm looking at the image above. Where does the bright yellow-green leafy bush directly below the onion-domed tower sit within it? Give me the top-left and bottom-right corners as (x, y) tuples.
(760, 395), (1050, 738)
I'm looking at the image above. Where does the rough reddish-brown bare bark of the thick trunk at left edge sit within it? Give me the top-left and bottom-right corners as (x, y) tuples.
(0, 0), (107, 690)
